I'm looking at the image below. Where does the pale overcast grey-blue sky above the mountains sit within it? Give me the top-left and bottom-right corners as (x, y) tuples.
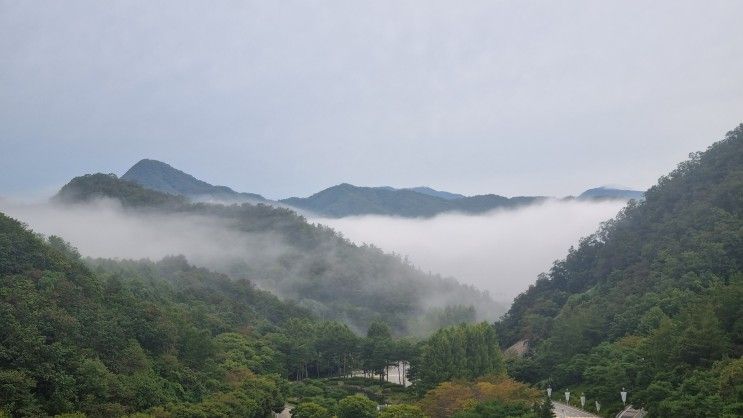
(0, 0), (743, 198)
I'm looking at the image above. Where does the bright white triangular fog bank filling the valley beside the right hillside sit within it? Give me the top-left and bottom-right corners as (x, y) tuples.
(314, 201), (625, 303)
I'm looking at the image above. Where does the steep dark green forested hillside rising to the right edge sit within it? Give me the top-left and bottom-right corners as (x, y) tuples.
(498, 125), (743, 417)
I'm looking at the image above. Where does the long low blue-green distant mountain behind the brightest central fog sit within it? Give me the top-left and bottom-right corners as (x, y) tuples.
(280, 183), (546, 218)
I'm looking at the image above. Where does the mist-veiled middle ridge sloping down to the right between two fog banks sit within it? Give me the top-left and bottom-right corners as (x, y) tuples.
(55, 174), (503, 334)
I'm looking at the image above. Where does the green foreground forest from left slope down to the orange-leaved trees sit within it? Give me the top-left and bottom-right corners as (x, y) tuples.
(0, 214), (539, 418)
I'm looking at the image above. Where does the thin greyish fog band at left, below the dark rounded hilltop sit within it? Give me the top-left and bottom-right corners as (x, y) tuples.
(0, 199), (286, 268)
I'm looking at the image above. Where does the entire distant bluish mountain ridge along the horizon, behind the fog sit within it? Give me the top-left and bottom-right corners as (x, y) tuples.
(121, 159), (643, 218)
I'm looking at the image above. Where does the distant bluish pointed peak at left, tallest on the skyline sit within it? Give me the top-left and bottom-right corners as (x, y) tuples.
(121, 159), (266, 203)
